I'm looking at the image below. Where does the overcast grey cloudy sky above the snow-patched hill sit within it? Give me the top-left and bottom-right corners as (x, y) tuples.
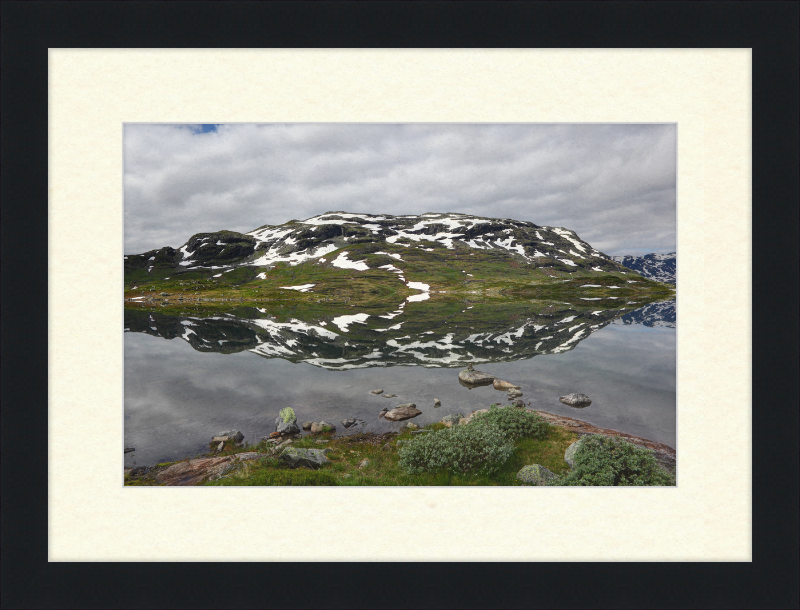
(124, 123), (677, 255)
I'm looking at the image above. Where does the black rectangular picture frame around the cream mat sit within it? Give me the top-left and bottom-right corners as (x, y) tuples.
(0, 1), (800, 608)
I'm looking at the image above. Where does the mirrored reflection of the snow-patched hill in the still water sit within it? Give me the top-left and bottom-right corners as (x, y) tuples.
(125, 301), (675, 371)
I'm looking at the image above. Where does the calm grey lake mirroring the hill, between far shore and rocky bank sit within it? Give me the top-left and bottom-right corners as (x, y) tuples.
(124, 299), (676, 467)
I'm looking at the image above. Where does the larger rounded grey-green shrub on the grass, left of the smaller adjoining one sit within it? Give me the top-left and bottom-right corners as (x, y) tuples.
(398, 425), (514, 474)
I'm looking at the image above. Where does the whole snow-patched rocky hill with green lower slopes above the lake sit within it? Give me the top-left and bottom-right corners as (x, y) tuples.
(124, 212), (656, 298)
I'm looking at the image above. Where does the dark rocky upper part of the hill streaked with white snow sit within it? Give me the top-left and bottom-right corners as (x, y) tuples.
(125, 212), (632, 273)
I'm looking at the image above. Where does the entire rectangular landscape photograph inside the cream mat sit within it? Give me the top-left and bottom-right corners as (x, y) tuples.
(120, 123), (677, 484)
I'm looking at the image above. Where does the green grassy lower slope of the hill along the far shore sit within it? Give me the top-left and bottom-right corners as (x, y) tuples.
(125, 242), (674, 307)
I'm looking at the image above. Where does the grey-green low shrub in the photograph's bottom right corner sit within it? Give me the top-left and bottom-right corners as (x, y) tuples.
(548, 434), (675, 486)
